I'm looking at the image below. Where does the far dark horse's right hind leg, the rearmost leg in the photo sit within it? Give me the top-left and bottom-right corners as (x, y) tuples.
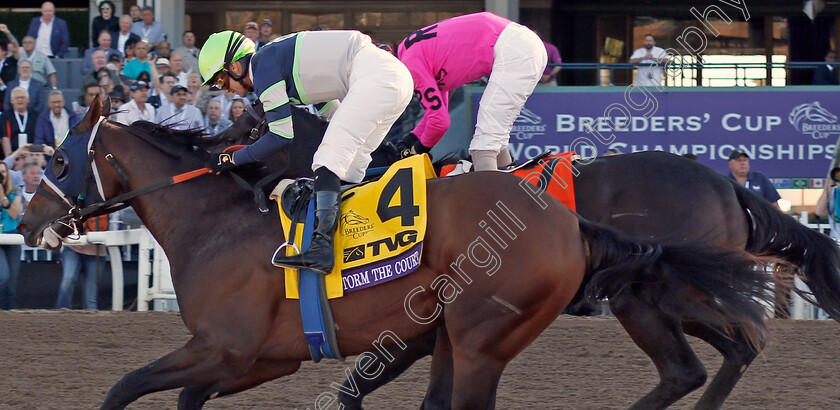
(683, 323), (765, 409)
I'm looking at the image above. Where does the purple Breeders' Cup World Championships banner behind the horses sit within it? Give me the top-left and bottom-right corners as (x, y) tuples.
(472, 86), (840, 178)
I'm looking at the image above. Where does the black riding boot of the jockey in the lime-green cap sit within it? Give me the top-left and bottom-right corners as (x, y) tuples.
(272, 167), (341, 275)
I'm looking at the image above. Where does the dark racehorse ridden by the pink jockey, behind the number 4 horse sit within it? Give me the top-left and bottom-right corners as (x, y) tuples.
(215, 100), (840, 409)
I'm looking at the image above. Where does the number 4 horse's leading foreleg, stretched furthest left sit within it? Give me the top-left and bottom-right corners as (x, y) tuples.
(101, 336), (256, 409)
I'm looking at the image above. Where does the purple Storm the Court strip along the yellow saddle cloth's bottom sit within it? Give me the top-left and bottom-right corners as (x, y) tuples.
(341, 242), (423, 293)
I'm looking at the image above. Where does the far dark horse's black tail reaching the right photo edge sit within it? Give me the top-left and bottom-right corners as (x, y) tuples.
(732, 182), (840, 322)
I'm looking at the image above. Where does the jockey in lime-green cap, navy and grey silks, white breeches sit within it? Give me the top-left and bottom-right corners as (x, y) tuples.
(198, 30), (411, 274)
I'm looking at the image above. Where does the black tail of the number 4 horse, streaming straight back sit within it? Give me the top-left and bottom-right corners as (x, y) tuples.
(580, 218), (774, 349)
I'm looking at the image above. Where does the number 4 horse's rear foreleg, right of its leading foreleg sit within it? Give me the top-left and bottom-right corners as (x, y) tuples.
(178, 360), (300, 410)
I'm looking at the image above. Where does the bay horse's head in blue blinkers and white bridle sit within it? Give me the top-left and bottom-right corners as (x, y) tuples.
(18, 96), (111, 249)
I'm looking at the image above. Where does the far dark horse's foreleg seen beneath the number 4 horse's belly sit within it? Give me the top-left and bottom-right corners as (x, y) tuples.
(338, 331), (437, 410)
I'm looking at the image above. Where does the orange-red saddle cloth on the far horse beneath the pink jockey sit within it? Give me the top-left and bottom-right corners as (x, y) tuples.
(440, 152), (579, 212)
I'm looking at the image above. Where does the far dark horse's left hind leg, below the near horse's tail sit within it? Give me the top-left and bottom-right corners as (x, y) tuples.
(610, 293), (706, 409)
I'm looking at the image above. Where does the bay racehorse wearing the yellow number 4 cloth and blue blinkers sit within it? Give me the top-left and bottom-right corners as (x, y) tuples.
(19, 99), (772, 409)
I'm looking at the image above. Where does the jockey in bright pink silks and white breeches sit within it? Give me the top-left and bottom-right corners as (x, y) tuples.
(397, 12), (548, 171)
